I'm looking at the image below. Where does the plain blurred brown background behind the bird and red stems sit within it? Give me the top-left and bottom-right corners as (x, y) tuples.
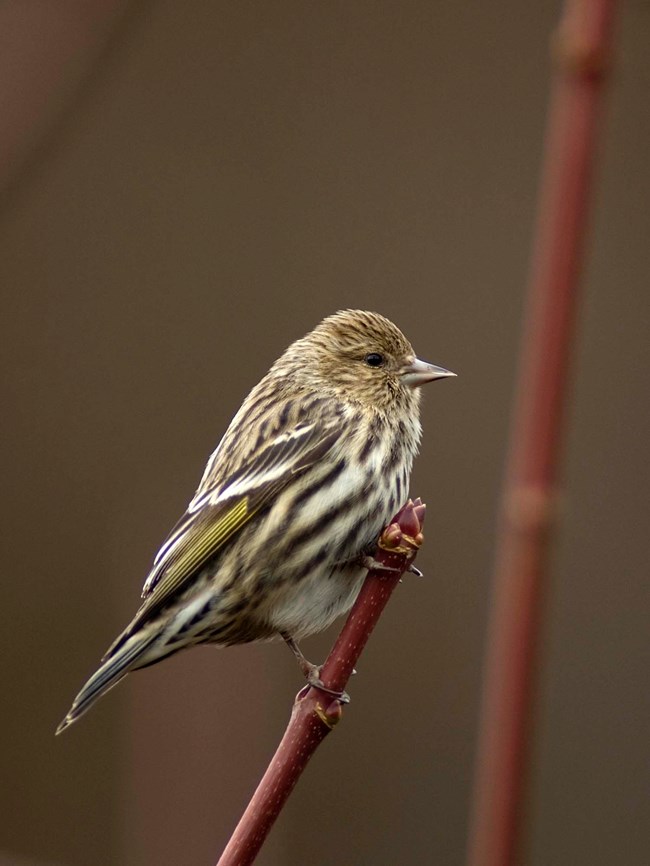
(0, 0), (650, 866)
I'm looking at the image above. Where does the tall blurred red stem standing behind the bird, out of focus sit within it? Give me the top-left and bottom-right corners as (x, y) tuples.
(468, 0), (616, 866)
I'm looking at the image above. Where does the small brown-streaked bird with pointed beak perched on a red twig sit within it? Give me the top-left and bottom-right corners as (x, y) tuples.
(56, 310), (456, 734)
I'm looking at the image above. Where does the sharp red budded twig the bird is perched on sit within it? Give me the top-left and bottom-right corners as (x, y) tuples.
(217, 499), (425, 866)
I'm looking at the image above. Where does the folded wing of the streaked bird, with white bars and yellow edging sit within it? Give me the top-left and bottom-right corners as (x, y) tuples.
(101, 418), (341, 655)
